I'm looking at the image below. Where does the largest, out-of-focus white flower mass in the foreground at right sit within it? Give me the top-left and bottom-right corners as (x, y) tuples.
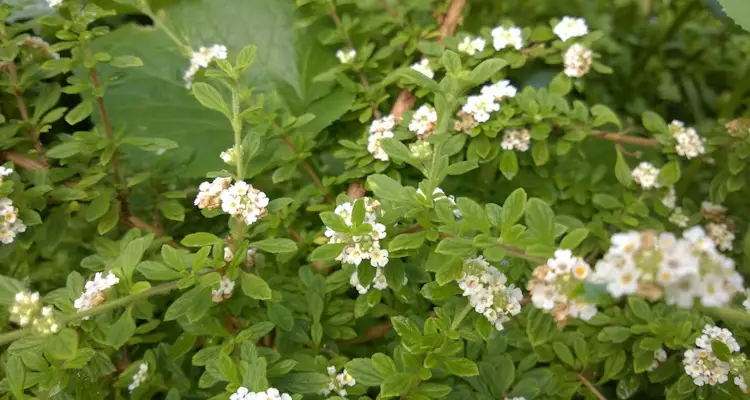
(594, 227), (742, 308)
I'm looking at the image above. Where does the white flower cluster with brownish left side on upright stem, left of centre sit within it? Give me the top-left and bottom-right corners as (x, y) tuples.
(195, 178), (268, 225)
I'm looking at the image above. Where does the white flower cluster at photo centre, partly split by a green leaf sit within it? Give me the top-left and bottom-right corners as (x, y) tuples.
(325, 197), (388, 268)
